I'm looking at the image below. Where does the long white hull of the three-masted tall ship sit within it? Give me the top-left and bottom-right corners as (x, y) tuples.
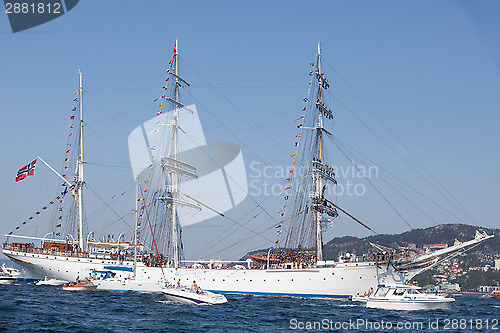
(4, 249), (412, 297)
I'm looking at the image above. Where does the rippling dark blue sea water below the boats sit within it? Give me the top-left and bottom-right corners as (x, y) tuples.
(0, 282), (500, 333)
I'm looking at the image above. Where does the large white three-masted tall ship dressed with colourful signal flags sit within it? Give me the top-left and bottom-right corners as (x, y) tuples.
(2, 42), (493, 297)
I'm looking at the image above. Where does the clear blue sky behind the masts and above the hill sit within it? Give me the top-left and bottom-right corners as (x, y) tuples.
(0, 0), (500, 258)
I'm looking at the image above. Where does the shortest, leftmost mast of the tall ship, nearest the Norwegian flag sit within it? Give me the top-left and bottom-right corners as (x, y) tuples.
(74, 70), (85, 251)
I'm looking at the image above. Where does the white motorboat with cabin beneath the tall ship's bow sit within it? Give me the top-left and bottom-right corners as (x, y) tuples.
(366, 284), (455, 311)
